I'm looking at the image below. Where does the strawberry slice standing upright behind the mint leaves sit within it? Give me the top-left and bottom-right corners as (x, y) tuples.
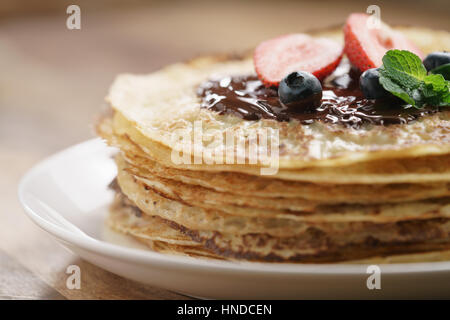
(344, 13), (423, 71)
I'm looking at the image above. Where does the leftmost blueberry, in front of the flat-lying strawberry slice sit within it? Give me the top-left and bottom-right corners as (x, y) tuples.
(278, 71), (322, 112)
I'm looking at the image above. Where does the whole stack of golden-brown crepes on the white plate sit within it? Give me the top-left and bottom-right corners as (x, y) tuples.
(97, 29), (450, 263)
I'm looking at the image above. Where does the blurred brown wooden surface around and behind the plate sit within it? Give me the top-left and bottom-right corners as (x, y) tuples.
(0, 1), (450, 299)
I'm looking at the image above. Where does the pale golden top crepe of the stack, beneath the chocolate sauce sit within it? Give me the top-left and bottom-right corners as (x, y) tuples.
(107, 28), (450, 172)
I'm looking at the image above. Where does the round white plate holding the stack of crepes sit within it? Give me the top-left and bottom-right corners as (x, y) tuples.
(19, 139), (450, 299)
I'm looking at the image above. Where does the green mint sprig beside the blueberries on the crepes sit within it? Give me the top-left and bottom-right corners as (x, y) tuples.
(380, 50), (450, 108)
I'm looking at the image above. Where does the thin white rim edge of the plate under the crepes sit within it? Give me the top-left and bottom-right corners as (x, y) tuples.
(18, 138), (450, 276)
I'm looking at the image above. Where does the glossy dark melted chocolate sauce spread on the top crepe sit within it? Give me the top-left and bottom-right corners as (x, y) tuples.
(197, 61), (439, 128)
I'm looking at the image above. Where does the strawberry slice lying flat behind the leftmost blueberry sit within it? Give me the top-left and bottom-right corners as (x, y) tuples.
(253, 34), (343, 86)
